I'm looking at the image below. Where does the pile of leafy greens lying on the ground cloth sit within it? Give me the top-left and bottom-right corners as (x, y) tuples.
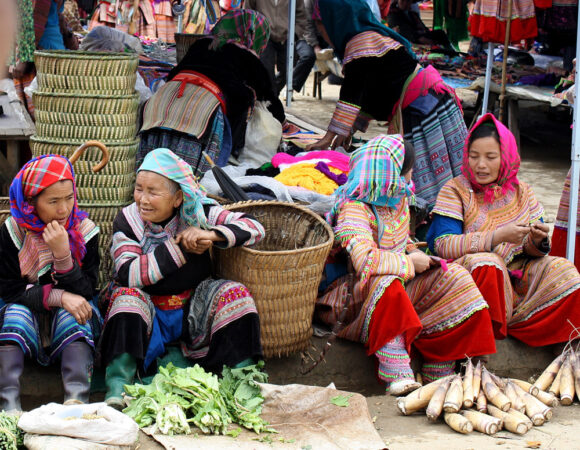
(123, 361), (273, 435)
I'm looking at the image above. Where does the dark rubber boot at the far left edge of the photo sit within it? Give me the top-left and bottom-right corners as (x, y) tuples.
(0, 345), (24, 412)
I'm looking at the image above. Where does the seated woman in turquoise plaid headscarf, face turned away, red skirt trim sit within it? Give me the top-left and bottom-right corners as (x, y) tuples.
(317, 135), (495, 395)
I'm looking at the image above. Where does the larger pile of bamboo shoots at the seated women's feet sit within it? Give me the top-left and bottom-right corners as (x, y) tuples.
(397, 360), (560, 435)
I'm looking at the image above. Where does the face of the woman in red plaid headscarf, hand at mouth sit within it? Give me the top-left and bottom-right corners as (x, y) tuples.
(29, 180), (75, 227)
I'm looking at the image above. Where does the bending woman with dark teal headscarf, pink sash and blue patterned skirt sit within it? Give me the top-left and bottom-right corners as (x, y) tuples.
(309, 0), (467, 213)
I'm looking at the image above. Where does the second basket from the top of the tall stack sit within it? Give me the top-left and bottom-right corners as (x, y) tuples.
(37, 72), (137, 95)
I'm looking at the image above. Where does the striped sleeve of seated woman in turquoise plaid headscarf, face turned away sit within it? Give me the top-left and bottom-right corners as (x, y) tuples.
(334, 201), (415, 283)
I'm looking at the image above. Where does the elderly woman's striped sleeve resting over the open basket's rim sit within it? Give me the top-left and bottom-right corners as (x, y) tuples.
(204, 205), (266, 248)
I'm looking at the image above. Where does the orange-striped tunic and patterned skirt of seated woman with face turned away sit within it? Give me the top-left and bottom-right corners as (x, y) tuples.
(318, 198), (487, 343)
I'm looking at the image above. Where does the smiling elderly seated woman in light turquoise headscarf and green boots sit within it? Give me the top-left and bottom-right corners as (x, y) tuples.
(100, 148), (264, 408)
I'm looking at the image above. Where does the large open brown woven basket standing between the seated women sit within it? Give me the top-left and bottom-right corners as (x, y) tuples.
(214, 201), (333, 358)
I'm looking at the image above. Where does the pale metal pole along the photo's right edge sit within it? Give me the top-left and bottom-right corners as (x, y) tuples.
(566, 8), (580, 262)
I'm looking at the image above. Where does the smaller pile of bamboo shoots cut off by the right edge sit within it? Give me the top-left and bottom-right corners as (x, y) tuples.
(533, 348), (580, 406)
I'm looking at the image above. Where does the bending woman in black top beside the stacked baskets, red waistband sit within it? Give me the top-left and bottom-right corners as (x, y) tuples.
(137, 9), (284, 175)
